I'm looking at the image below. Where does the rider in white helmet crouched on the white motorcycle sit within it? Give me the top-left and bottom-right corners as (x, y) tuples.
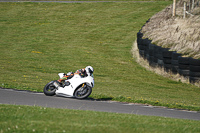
(58, 66), (94, 82)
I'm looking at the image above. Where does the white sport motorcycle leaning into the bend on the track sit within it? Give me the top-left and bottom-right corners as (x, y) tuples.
(44, 73), (94, 99)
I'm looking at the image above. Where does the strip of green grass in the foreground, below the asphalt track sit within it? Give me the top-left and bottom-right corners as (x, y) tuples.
(0, 105), (200, 133)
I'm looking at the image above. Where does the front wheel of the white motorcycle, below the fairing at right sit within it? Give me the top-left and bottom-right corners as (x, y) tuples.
(74, 85), (92, 99)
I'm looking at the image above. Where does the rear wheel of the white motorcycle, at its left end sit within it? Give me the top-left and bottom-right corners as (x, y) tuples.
(43, 81), (56, 96)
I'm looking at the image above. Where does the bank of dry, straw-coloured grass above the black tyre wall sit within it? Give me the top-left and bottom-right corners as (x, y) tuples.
(141, 0), (200, 59)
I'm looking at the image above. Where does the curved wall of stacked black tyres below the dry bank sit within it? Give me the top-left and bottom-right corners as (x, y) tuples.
(137, 31), (200, 83)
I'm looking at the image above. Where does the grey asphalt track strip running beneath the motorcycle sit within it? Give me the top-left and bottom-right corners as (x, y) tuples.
(0, 88), (200, 120)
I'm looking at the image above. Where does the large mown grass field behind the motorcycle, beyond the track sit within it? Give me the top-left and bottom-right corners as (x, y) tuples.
(0, 2), (200, 110)
